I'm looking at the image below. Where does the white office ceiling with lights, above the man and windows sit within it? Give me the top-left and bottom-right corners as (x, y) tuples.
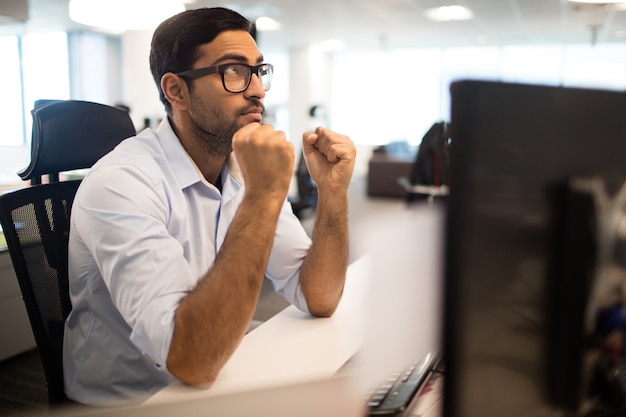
(0, 0), (626, 50)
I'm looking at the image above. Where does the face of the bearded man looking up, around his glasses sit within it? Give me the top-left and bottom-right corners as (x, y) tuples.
(184, 30), (265, 156)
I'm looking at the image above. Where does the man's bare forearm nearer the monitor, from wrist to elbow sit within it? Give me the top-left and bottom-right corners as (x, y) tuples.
(300, 193), (349, 317)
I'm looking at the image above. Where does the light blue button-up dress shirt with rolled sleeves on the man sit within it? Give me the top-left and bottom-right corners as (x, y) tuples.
(63, 118), (311, 405)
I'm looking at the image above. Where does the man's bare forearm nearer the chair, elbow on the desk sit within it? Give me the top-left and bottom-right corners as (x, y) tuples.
(167, 193), (282, 385)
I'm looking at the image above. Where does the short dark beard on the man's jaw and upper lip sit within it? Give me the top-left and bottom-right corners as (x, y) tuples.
(190, 95), (263, 158)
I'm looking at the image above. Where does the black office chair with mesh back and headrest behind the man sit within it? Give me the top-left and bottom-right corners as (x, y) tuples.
(0, 100), (135, 404)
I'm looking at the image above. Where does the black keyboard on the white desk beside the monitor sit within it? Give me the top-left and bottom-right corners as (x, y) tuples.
(360, 353), (439, 416)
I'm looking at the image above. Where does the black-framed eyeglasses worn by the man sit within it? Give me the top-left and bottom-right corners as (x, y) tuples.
(176, 64), (274, 93)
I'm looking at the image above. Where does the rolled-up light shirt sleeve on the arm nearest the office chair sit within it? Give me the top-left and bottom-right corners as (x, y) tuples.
(73, 165), (198, 366)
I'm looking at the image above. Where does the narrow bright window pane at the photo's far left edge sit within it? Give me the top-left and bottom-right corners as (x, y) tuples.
(0, 36), (24, 146)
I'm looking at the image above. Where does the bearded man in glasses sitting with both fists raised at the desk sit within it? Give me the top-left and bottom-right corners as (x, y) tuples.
(64, 8), (356, 404)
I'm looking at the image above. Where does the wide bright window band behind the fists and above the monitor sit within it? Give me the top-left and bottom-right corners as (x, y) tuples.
(331, 44), (626, 145)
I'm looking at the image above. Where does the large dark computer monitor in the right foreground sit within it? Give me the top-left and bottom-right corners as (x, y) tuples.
(443, 80), (626, 417)
